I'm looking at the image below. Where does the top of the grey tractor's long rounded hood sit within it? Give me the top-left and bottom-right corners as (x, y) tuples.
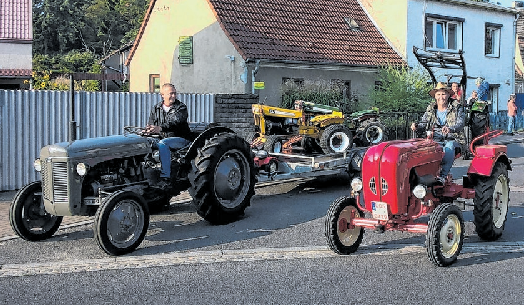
(40, 134), (151, 163)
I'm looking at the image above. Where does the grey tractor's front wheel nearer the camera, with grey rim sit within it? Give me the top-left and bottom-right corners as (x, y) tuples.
(93, 191), (149, 256)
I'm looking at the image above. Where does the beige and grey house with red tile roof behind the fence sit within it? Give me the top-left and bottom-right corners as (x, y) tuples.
(126, 0), (405, 105)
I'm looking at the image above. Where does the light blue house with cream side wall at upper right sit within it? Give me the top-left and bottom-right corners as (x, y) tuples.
(360, 0), (518, 112)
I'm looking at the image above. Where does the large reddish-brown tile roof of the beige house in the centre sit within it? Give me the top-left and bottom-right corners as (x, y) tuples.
(126, 0), (405, 66)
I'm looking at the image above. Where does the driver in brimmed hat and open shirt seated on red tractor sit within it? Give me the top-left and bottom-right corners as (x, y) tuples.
(411, 82), (464, 180)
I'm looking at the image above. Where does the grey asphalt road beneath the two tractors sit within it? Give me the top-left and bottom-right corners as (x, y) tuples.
(0, 140), (524, 304)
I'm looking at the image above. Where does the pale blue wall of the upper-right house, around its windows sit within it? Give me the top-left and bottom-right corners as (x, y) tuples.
(407, 0), (515, 112)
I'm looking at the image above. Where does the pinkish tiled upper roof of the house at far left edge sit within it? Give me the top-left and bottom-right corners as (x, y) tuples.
(0, 0), (33, 40)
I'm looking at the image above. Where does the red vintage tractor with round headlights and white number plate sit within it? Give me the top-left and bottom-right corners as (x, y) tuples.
(325, 131), (511, 266)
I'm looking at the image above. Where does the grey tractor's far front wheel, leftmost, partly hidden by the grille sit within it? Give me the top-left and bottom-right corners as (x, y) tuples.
(9, 181), (63, 241)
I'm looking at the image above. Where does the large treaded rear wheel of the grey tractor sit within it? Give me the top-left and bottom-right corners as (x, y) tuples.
(189, 134), (256, 224)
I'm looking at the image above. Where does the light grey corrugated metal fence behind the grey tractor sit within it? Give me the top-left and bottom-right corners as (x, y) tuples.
(0, 90), (215, 191)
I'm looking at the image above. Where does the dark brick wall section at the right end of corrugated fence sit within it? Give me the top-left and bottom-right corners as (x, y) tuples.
(214, 94), (258, 137)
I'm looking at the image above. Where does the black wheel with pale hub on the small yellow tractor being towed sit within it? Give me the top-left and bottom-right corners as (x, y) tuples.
(320, 124), (353, 154)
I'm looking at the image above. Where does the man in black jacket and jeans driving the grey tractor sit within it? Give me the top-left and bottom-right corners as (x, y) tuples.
(145, 83), (191, 188)
